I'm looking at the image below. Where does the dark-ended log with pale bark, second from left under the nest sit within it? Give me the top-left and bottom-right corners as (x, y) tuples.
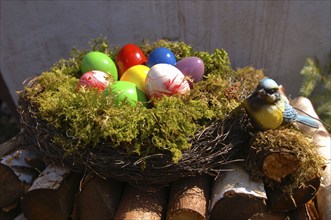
(22, 166), (81, 220)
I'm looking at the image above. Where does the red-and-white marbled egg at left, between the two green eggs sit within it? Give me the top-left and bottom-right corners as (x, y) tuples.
(78, 70), (110, 91)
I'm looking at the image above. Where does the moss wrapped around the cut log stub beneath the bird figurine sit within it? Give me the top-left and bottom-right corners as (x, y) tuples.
(246, 128), (325, 192)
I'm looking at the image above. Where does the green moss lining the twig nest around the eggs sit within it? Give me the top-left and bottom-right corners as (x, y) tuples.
(21, 39), (263, 162)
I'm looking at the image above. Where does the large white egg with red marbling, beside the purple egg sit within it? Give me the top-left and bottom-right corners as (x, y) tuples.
(145, 63), (190, 98)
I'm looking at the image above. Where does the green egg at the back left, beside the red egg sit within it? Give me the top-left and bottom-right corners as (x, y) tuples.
(81, 51), (118, 81)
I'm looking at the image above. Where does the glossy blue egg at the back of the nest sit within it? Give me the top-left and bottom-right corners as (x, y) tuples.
(147, 47), (176, 67)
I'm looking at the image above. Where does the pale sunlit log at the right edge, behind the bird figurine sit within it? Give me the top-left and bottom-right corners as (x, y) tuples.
(292, 97), (331, 220)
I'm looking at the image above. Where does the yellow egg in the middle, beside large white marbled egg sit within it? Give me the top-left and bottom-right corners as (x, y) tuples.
(120, 65), (149, 93)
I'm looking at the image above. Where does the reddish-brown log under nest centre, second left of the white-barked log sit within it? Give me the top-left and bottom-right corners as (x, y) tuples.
(115, 184), (168, 220)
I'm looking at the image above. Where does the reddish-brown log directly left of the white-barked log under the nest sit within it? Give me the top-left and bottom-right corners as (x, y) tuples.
(167, 176), (211, 220)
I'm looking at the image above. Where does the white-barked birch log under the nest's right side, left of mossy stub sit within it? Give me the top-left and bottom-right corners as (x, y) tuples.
(210, 165), (267, 220)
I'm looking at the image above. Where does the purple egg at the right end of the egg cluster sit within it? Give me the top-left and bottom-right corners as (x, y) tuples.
(175, 57), (205, 88)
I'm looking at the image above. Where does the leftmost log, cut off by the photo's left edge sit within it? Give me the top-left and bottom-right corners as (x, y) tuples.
(0, 150), (42, 208)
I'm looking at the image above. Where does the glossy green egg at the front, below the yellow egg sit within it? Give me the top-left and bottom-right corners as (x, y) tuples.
(111, 81), (148, 106)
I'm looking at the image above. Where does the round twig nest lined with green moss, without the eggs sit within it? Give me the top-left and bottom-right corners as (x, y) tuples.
(18, 38), (264, 187)
